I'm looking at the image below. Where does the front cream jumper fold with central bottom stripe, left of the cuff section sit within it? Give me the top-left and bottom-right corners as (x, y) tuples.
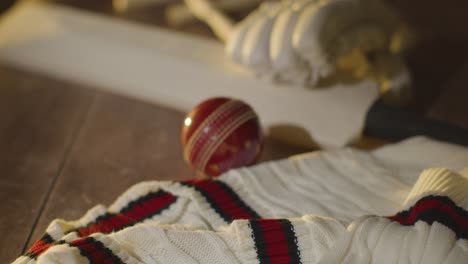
(29, 216), (346, 263)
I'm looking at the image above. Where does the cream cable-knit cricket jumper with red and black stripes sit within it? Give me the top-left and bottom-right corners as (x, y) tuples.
(15, 139), (468, 263)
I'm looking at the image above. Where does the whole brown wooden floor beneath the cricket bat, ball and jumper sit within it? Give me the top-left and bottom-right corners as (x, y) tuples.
(0, 1), (468, 263)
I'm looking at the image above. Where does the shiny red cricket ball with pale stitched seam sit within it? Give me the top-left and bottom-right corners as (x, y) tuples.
(181, 97), (263, 177)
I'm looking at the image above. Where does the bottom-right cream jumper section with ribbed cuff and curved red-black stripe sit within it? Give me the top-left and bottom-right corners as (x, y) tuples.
(320, 169), (468, 264)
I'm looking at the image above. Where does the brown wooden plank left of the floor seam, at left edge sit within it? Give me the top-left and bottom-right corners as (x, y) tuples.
(0, 67), (93, 263)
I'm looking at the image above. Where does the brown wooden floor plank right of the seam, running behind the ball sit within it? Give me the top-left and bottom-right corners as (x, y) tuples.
(30, 91), (304, 248)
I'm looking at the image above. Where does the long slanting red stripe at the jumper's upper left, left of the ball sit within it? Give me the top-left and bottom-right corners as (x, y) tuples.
(77, 193), (177, 237)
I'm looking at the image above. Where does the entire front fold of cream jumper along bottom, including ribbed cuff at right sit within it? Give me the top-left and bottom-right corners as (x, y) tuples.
(19, 169), (468, 263)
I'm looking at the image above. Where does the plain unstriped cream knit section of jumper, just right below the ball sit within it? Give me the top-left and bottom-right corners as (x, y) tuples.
(220, 149), (419, 222)
